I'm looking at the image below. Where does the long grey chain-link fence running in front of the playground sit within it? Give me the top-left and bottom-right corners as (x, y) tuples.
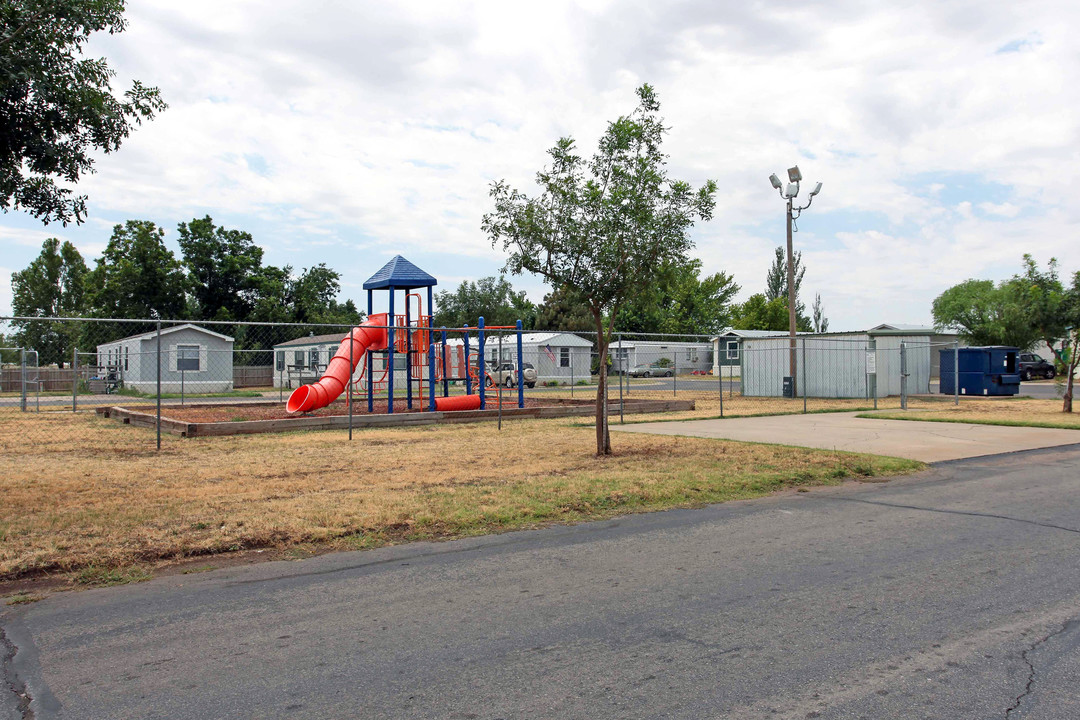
(0, 315), (980, 449)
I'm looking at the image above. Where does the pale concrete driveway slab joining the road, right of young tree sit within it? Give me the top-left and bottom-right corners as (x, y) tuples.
(611, 412), (1080, 462)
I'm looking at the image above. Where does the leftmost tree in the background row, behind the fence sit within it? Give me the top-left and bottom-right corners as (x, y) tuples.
(11, 237), (86, 367)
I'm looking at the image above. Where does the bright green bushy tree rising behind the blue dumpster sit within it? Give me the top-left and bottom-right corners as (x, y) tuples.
(932, 280), (1040, 350)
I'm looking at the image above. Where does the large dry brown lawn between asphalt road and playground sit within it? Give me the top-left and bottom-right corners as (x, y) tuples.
(0, 413), (920, 579)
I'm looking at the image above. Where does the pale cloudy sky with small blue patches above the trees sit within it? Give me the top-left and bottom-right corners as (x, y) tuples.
(0, 0), (1080, 329)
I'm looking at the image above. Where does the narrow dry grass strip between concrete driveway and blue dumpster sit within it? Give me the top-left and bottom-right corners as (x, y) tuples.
(873, 397), (1080, 430)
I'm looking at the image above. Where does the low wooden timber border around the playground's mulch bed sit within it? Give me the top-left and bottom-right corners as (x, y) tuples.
(97, 398), (694, 437)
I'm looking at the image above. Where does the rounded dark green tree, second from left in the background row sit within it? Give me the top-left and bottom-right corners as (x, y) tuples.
(86, 220), (188, 320)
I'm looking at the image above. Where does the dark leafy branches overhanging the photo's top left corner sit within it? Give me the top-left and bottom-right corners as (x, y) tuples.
(0, 0), (166, 225)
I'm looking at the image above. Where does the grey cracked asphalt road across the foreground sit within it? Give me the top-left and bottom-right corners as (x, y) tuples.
(6, 446), (1080, 720)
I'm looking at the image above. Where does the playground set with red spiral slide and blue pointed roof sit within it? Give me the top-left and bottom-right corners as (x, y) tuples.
(285, 255), (525, 415)
